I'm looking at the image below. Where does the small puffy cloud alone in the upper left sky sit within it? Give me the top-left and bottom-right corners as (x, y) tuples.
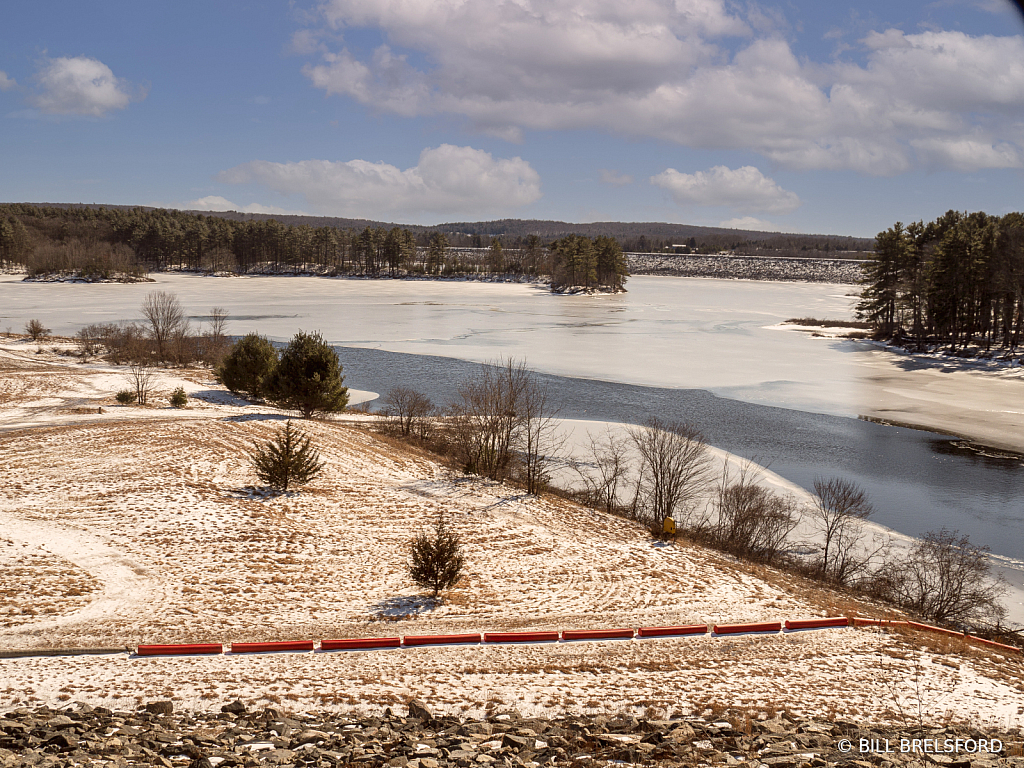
(29, 56), (145, 118)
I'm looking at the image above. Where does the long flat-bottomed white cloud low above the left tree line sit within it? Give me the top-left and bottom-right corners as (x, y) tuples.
(217, 144), (541, 218)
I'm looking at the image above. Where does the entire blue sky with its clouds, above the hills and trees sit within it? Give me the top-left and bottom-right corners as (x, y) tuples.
(0, 0), (1024, 237)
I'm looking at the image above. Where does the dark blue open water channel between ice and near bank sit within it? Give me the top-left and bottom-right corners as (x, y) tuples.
(336, 346), (1024, 561)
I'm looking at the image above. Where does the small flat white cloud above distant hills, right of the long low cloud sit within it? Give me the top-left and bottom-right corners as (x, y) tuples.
(650, 165), (800, 214)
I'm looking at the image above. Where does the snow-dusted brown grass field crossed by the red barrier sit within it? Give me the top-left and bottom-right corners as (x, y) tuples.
(0, 342), (1024, 728)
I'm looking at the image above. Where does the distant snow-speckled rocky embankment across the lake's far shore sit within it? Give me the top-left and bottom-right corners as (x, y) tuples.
(626, 253), (863, 285)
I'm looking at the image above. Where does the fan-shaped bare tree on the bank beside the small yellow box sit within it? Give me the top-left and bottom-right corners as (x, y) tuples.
(629, 418), (712, 530)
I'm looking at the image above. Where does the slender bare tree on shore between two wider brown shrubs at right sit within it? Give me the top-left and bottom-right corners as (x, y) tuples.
(814, 477), (874, 584)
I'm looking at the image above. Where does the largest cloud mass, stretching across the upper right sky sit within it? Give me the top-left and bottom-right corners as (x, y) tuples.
(303, 0), (1024, 175)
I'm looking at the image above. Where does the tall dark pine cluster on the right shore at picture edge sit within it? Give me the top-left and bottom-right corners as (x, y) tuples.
(857, 211), (1024, 351)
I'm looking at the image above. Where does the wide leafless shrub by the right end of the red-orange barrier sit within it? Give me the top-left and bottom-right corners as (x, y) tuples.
(874, 528), (1006, 629)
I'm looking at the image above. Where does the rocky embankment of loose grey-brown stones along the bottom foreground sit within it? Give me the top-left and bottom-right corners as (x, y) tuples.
(0, 700), (1024, 768)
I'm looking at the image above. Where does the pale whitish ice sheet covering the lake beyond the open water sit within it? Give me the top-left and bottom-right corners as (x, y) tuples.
(0, 274), (863, 417)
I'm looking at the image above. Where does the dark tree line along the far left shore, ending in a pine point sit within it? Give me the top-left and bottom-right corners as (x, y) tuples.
(0, 205), (628, 290)
